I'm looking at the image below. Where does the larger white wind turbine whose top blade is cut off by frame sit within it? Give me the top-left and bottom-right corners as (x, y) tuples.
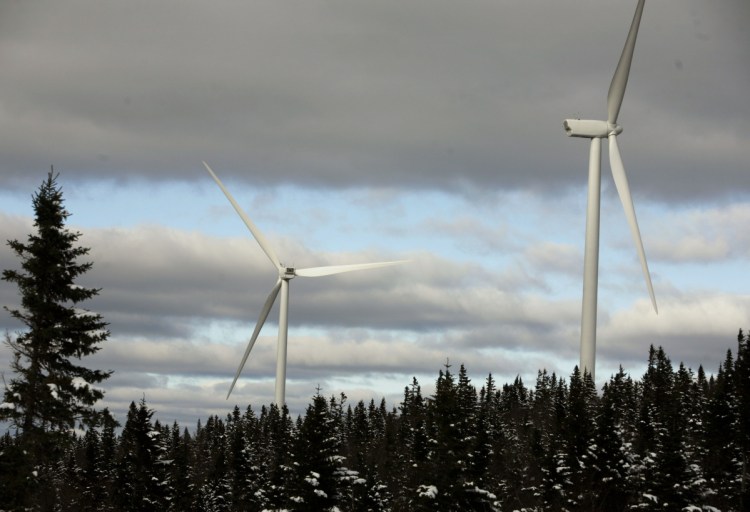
(563, 0), (659, 379)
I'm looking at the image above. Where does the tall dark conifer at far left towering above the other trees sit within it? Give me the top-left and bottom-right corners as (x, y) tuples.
(0, 171), (111, 506)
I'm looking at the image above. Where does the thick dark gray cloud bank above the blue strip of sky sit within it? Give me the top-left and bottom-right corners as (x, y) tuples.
(0, 0), (750, 200)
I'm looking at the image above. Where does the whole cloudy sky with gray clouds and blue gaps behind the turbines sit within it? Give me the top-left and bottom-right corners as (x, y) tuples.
(0, 0), (750, 427)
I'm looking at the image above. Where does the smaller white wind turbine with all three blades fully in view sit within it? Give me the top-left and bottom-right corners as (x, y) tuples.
(203, 162), (406, 406)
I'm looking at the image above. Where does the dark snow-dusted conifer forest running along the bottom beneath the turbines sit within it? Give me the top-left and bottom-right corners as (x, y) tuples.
(0, 331), (750, 512)
